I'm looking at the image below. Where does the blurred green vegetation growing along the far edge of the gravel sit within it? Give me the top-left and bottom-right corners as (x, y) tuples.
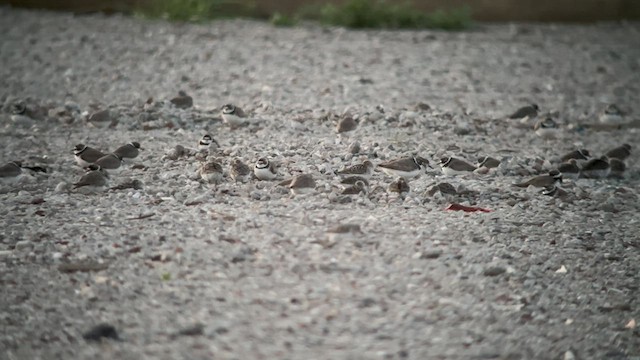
(136, 0), (472, 30)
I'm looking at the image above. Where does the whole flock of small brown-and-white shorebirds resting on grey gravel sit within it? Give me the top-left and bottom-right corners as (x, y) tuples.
(0, 98), (631, 200)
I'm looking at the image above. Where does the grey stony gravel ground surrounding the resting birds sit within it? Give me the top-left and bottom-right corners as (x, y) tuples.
(0, 8), (640, 360)
